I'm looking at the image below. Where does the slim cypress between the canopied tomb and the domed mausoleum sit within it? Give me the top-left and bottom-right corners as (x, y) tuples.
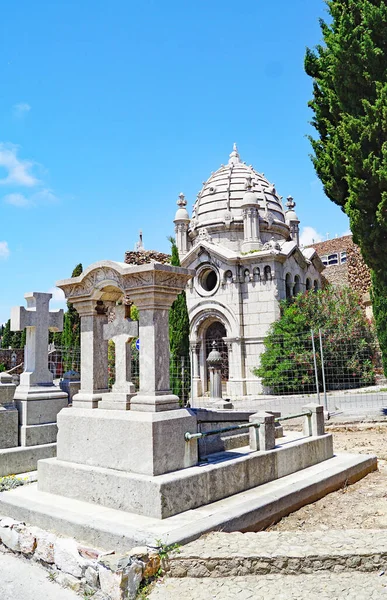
(168, 237), (190, 404)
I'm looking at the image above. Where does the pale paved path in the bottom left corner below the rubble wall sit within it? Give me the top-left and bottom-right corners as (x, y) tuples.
(0, 553), (80, 600)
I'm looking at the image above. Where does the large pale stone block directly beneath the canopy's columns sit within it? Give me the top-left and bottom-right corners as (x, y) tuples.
(51, 407), (197, 475)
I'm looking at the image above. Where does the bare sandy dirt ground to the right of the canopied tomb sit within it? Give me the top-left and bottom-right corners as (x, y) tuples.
(269, 423), (387, 531)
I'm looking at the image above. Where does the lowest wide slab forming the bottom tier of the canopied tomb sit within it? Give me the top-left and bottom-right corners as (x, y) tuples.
(0, 454), (377, 552)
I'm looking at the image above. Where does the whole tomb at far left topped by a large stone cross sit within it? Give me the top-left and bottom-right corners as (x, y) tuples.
(0, 292), (68, 476)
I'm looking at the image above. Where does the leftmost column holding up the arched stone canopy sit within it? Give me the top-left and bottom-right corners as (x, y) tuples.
(72, 299), (109, 408)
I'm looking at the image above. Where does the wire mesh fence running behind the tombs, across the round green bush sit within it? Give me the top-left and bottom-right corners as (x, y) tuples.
(1, 330), (387, 415)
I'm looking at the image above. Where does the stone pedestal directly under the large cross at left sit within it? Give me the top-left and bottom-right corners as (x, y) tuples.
(15, 386), (68, 446)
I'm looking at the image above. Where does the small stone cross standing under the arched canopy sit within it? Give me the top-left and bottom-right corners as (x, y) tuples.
(98, 304), (138, 410)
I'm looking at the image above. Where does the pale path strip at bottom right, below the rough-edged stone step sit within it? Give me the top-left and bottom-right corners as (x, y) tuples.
(148, 572), (387, 600)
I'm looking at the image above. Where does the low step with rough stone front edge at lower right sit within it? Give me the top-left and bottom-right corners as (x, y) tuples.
(169, 529), (387, 578)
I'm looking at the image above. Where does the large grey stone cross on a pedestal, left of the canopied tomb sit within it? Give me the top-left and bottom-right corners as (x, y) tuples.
(11, 292), (63, 387)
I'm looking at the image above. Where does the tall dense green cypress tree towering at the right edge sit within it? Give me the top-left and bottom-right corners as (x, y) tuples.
(305, 0), (387, 375)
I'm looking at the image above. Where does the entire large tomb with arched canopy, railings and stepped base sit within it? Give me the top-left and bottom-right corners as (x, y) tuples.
(0, 261), (376, 550)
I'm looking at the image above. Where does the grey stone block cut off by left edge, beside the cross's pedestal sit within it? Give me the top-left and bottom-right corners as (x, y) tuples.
(0, 373), (18, 449)
